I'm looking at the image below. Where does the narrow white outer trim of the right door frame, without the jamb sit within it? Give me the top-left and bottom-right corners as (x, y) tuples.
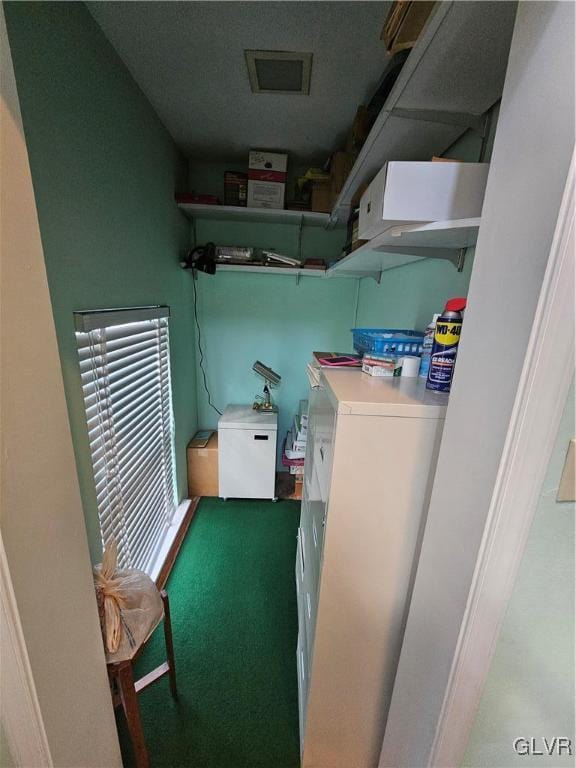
(429, 154), (576, 768)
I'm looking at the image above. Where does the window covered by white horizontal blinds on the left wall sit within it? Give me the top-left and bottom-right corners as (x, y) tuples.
(74, 307), (176, 573)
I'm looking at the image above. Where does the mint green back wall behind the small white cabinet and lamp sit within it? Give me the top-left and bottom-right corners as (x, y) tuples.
(190, 237), (472, 456)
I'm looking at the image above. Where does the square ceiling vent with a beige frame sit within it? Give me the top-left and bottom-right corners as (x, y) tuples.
(244, 51), (312, 96)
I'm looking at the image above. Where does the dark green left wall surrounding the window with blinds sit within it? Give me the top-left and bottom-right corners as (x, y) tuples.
(4, 2), (196, 559)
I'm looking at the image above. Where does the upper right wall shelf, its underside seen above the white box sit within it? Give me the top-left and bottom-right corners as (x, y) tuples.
(331, 1), (516, 224)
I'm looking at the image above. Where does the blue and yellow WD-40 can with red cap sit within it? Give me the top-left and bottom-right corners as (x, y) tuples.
(426, 299), (466, 392)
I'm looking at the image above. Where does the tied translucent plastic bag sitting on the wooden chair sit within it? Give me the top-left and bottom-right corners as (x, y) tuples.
(94, 541), (164, 663)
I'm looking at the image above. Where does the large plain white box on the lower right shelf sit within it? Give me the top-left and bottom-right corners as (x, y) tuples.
(358, 161), (490, 240)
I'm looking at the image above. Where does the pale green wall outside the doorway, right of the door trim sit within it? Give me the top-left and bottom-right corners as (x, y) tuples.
(462, 382), (576, 768)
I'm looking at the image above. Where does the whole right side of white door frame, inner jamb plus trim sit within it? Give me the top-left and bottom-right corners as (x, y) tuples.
(380, 2), (574, 768)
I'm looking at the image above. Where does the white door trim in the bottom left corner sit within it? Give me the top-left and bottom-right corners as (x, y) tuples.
(0, 533), (53, 768)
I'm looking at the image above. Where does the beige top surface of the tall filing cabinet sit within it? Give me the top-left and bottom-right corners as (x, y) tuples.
(322, 368), (448, 419)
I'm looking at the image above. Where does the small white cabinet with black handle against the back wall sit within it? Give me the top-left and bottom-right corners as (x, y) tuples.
(218, 405), (278, 500)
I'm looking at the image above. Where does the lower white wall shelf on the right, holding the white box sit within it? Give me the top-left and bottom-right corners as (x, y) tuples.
(327, 219), (480, 280)
